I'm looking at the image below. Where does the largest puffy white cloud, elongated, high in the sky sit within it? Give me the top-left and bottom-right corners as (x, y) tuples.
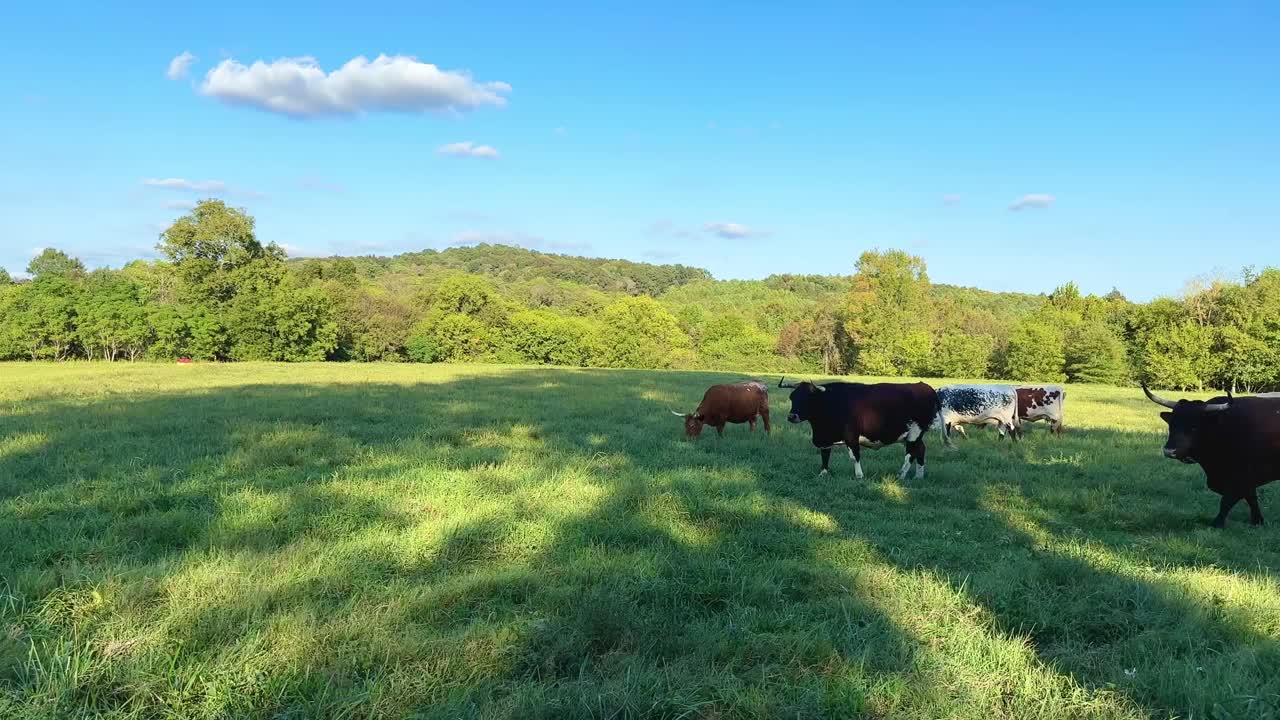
(200, 55), (511, 118)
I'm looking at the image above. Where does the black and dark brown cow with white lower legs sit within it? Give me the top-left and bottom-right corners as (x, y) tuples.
(778, 378), (938, 479)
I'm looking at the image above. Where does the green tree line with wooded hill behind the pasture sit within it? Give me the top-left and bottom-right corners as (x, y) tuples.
(0, 200), (1280, 391)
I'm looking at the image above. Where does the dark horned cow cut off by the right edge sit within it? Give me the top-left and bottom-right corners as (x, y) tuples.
(1142, 386), (1280, 528)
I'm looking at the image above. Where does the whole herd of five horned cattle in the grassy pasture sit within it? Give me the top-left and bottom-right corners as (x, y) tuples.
(672, 378), (1280, 528)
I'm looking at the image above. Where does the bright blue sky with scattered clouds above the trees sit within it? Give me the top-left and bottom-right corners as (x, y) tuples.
(0, 1), (1280, 299)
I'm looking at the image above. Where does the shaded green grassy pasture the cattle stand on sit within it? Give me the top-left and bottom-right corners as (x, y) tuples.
(0, 364), (1280, 719)
